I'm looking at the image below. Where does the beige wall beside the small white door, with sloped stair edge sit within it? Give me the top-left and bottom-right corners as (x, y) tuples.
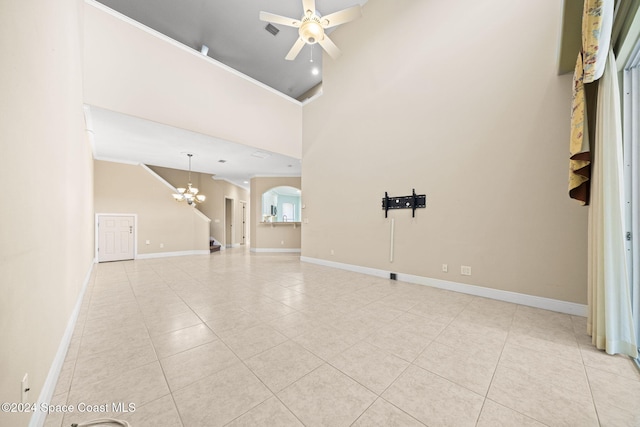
(94, 160), (209, 255)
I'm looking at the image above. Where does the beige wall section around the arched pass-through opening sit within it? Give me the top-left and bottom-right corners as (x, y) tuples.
(250, 177), (304, 251)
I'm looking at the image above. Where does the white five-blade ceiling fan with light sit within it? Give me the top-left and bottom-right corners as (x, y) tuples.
(260, 0), (362, 61)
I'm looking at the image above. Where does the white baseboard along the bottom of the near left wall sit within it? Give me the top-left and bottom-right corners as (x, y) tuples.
(29, 259), (97, 427)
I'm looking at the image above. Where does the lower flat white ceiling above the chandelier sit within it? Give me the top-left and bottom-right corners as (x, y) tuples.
(85, 106), (301, 189)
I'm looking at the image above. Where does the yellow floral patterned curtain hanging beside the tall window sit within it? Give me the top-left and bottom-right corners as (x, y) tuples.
(569, 0), (614, 205)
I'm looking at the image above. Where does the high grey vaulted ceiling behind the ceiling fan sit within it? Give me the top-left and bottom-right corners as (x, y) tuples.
(98, 0), (366, 99)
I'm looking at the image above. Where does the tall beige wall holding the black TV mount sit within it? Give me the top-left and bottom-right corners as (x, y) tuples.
(302, 0), (587, 304)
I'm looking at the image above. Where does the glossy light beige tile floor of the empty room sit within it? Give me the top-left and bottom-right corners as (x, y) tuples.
(46, 249), (640, 427)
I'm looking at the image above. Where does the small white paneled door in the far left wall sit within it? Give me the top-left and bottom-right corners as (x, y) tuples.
(98, 215), (134, 262)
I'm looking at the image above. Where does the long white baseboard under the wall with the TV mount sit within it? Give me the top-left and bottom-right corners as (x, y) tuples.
(300, 256), (587, 317)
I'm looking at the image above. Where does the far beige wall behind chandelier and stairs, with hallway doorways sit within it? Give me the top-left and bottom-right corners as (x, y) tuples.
(149, 166), (249, 246)
